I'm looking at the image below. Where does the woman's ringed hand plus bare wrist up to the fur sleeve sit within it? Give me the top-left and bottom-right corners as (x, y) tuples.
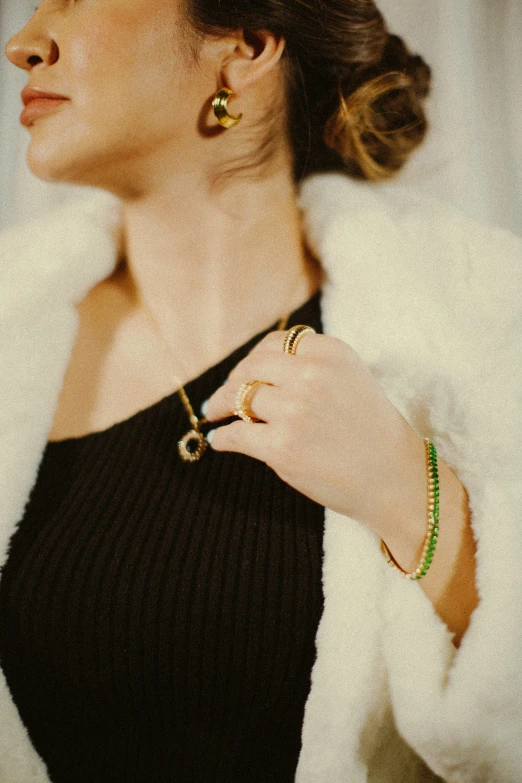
(206, 332), (478, 646)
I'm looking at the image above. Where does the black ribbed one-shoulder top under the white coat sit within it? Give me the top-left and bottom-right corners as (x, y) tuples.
(0, 292), (324, 783)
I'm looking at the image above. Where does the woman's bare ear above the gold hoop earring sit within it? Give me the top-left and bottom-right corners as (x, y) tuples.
(220, 30), (286, 95)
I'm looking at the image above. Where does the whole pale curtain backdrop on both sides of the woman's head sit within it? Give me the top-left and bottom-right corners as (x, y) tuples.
(0, 0), (522, 234)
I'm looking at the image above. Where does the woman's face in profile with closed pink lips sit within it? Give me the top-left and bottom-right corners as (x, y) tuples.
(6, 0), (230, 189)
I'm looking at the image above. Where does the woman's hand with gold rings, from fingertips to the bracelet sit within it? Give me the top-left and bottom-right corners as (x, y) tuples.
(206, 332), (426, 541)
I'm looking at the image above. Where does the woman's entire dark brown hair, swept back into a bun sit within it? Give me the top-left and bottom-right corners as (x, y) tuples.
(183, 0), (430, 181)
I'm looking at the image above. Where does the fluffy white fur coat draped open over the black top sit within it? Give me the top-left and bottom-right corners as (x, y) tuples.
(0, 174), (522, 783)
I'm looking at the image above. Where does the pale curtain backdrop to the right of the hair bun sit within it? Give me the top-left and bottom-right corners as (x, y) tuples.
(378, 0), (522, 239)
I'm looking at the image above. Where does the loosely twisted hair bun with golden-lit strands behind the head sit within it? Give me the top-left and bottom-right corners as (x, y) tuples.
(323, 35), (431, 180)
